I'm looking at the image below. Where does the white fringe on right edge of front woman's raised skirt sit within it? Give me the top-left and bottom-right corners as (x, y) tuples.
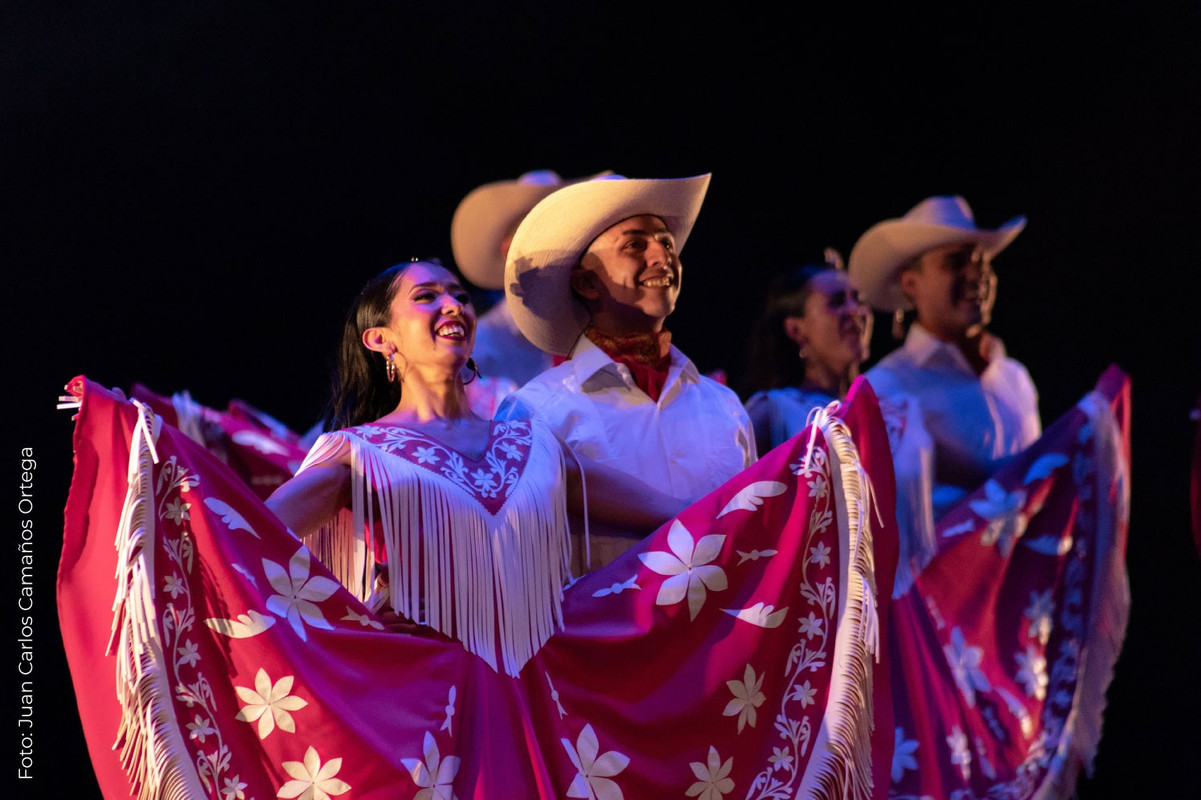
(799, 402), (880, 800)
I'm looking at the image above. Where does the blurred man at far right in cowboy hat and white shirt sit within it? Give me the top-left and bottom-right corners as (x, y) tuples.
(848, 196), (1041, 516)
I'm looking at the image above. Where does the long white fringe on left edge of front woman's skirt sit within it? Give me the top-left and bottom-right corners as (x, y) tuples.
(108, 400), (208, 800)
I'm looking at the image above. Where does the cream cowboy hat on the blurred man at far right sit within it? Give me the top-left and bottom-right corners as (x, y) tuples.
(847, 195), (1026, 311)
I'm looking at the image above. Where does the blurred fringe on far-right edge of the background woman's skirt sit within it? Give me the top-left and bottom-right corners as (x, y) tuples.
(1032, 392), (1130, 800)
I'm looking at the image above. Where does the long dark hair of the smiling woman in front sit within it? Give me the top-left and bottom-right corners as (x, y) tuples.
(324, 258), (427, 430)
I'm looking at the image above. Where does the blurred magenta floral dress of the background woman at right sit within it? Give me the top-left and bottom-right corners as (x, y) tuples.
(748, 365), (1129, 800)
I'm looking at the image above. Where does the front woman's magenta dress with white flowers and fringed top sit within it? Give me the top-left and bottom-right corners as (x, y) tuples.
(59, 378), (895, 800)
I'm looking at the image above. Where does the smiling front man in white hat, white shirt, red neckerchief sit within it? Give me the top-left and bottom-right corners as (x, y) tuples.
(498, 175), (755, 571)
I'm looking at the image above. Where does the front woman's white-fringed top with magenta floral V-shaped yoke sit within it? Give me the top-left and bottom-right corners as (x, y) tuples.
(299, 420), (570, 676)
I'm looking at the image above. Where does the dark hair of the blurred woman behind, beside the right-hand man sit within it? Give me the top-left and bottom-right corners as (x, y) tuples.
(741, 256), (835, 400)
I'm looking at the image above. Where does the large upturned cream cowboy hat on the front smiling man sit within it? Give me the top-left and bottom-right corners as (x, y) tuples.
(504, 174), (710, 356)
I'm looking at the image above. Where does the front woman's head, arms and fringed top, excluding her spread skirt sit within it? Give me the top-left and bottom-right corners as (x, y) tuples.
(267, 262), (683, 653)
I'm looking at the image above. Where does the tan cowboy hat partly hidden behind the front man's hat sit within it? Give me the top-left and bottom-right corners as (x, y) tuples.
(450, 169), (609, 289)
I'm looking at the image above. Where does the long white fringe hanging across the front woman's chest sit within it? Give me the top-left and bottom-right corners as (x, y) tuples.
(305, 426), (570, 676)
